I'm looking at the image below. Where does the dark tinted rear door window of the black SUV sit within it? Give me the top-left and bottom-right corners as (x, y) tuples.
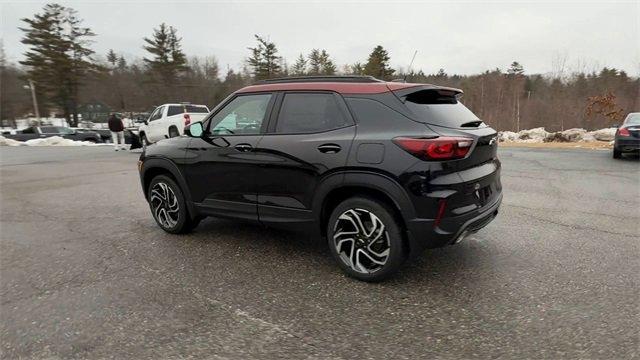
(276, 93), (350, 134)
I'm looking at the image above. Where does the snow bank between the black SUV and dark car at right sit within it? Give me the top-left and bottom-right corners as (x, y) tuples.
(498, 128), (616, 143)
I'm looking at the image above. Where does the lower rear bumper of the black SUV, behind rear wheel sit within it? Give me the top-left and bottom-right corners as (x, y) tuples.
(407, 193), (502, 256)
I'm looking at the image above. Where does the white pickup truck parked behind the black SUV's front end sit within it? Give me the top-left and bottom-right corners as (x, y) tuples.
(139, 103), (209, 144)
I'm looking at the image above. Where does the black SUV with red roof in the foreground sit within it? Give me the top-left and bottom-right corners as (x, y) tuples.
(139, 77), (502, 281)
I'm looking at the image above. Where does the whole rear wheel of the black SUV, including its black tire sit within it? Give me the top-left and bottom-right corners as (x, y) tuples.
(327, 197), (407, 282)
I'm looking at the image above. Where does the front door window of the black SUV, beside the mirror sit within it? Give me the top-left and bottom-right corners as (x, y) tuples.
(209, 94), (272, 135)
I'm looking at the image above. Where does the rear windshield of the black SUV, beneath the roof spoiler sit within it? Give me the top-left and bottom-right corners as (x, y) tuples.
(403, 89), (484, 128)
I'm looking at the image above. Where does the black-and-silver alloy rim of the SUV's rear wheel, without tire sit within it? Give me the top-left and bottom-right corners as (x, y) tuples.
(333, 209), (391, 274)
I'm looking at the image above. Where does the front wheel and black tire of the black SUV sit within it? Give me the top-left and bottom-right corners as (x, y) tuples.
(147, 175), (201, 234)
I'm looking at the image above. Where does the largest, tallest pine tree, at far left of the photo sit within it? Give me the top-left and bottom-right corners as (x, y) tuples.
(20, 4), (95, 126)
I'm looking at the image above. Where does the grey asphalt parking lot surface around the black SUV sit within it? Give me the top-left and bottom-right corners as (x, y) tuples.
(0, 147), (640, 359)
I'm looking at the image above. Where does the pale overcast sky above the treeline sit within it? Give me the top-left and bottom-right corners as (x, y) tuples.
(0, 0), (640, 76)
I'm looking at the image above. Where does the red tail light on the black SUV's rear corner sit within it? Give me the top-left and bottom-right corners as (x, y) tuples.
(393, 136), (473, 160)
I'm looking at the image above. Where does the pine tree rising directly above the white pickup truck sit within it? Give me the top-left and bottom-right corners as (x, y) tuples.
(143, 23), (187, 86)
